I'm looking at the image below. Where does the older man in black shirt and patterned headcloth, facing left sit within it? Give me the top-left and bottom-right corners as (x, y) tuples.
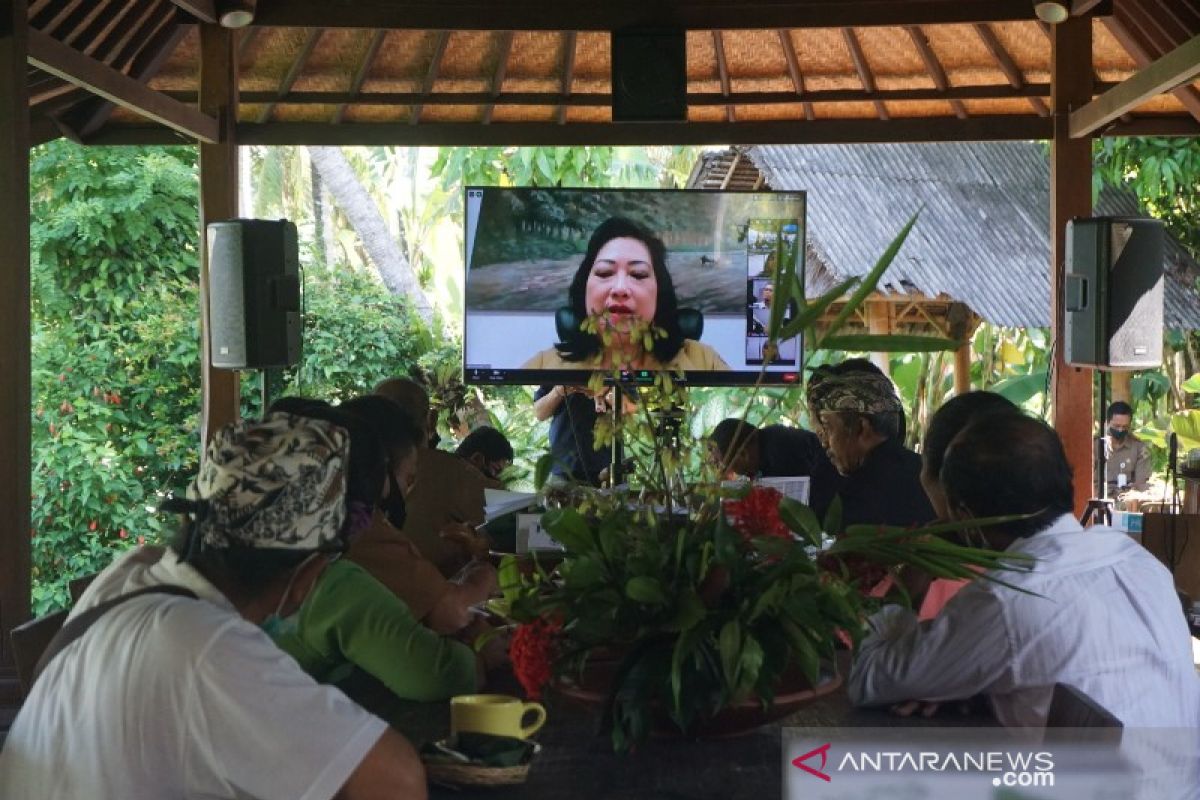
(808, 359), (935, 534)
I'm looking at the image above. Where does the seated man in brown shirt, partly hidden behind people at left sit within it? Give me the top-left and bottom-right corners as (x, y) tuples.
(373, 378), (486, 577)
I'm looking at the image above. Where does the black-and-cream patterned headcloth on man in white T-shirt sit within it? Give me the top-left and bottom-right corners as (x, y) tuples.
(187, 413), (350, 551)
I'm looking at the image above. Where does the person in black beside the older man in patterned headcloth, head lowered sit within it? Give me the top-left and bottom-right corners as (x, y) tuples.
(708, 419), (840, 517)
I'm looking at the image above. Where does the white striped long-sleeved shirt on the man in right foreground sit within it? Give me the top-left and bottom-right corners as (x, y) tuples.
(848, 516), (1200, 728)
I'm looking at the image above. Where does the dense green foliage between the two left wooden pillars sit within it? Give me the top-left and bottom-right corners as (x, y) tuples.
(30, 142), (199, 613)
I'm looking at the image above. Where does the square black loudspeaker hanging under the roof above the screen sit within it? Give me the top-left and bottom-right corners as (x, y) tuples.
(612, 29), (688, 122)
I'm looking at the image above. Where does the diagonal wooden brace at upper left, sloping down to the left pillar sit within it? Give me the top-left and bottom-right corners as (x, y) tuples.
(29, 30), (217, 142)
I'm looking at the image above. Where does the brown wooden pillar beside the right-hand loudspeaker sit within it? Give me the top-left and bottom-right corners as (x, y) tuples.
(1050, 17), (1094, 513)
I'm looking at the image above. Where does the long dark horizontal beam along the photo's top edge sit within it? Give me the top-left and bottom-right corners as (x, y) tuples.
(254, 0), (1034, 31)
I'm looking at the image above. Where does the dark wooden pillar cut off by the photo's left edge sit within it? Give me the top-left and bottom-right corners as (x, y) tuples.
(0, 0), (31, 676)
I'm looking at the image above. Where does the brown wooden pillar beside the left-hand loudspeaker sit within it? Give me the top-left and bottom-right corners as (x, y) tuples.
(200, 25), (240, 447)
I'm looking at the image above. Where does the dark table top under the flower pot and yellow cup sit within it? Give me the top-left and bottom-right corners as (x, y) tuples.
(374, 657), (996, 800)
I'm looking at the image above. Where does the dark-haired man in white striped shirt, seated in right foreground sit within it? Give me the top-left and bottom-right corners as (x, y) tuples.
(848, 414), (1200, 728)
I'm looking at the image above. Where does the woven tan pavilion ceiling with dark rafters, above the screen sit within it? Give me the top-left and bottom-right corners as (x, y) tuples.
(21, 0), (1200, 145)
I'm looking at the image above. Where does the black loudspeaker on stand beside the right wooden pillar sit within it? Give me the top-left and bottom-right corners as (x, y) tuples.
(1063, 217), (1164, 369)
